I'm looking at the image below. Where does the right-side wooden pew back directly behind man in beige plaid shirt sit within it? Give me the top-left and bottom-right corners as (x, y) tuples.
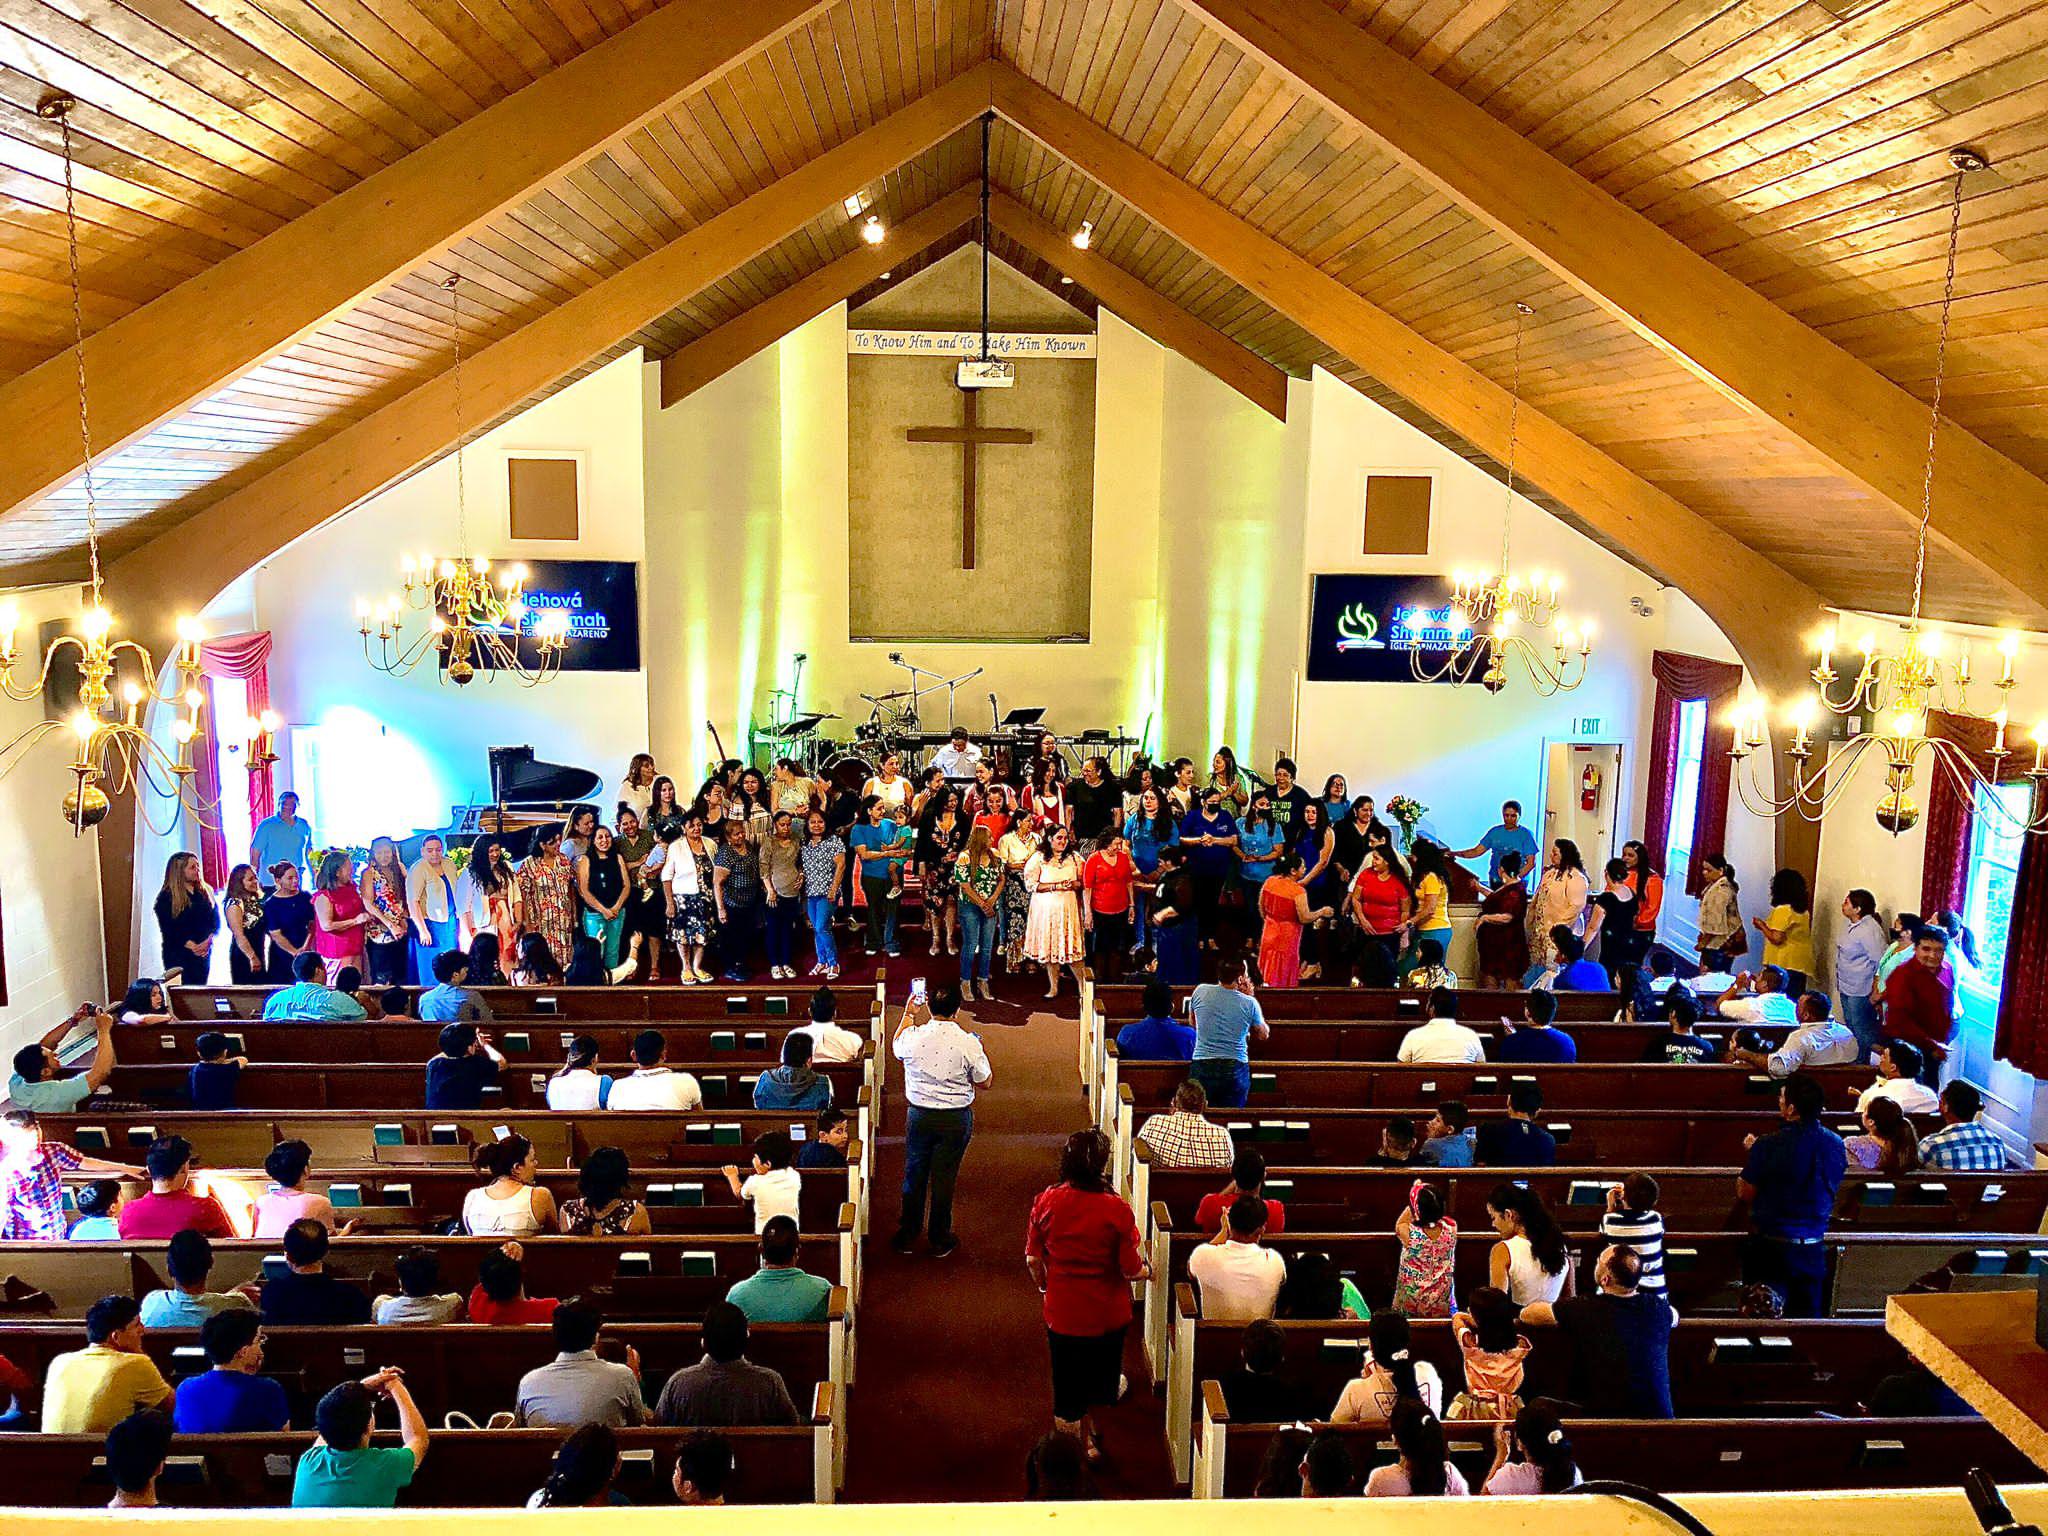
(1137, 1147), (2048, 1233)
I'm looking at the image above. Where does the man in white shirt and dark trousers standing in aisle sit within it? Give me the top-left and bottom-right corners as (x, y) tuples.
(889, 981), (993, 1260)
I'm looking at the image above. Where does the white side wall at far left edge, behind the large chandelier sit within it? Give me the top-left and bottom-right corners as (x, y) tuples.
(0, 588), (119, 1055)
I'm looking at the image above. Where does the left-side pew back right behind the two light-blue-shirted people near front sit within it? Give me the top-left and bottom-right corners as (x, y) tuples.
(115, 1024), (879, 1077)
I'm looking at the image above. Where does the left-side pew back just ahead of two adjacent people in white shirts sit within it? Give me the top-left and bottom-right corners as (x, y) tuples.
(106, 1056), (868, 1118)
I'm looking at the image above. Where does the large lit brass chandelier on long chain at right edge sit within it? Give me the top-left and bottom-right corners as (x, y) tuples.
(1731, 150), (2048, 836)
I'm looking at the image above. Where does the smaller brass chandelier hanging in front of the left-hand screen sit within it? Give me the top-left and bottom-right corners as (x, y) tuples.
(356, 274), (569, 688)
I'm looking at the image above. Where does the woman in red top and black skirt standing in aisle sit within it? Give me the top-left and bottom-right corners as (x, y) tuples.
(1024, 1130), (1147, 1464)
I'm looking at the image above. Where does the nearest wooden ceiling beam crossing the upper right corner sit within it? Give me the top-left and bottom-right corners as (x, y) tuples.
(1180, 0), (2048, 621)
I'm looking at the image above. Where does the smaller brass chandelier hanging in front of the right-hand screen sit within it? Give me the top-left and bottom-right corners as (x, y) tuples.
(1395, 301), (1593, 698)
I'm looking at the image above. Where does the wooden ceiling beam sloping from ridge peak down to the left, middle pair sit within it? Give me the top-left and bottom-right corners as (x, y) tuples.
(109, 66), (989, 631)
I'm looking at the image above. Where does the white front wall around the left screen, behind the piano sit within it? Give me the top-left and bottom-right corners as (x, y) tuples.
(243, 352), (659, 836)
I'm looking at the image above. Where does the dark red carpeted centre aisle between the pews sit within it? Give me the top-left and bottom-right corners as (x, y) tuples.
(827, 946), (1171, 1503)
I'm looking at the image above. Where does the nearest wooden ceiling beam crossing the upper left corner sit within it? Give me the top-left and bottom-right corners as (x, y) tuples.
(0, 0), (831, 518)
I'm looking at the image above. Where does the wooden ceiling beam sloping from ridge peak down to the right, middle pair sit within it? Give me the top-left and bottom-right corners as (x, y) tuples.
(995, 63), (1823, 872)
